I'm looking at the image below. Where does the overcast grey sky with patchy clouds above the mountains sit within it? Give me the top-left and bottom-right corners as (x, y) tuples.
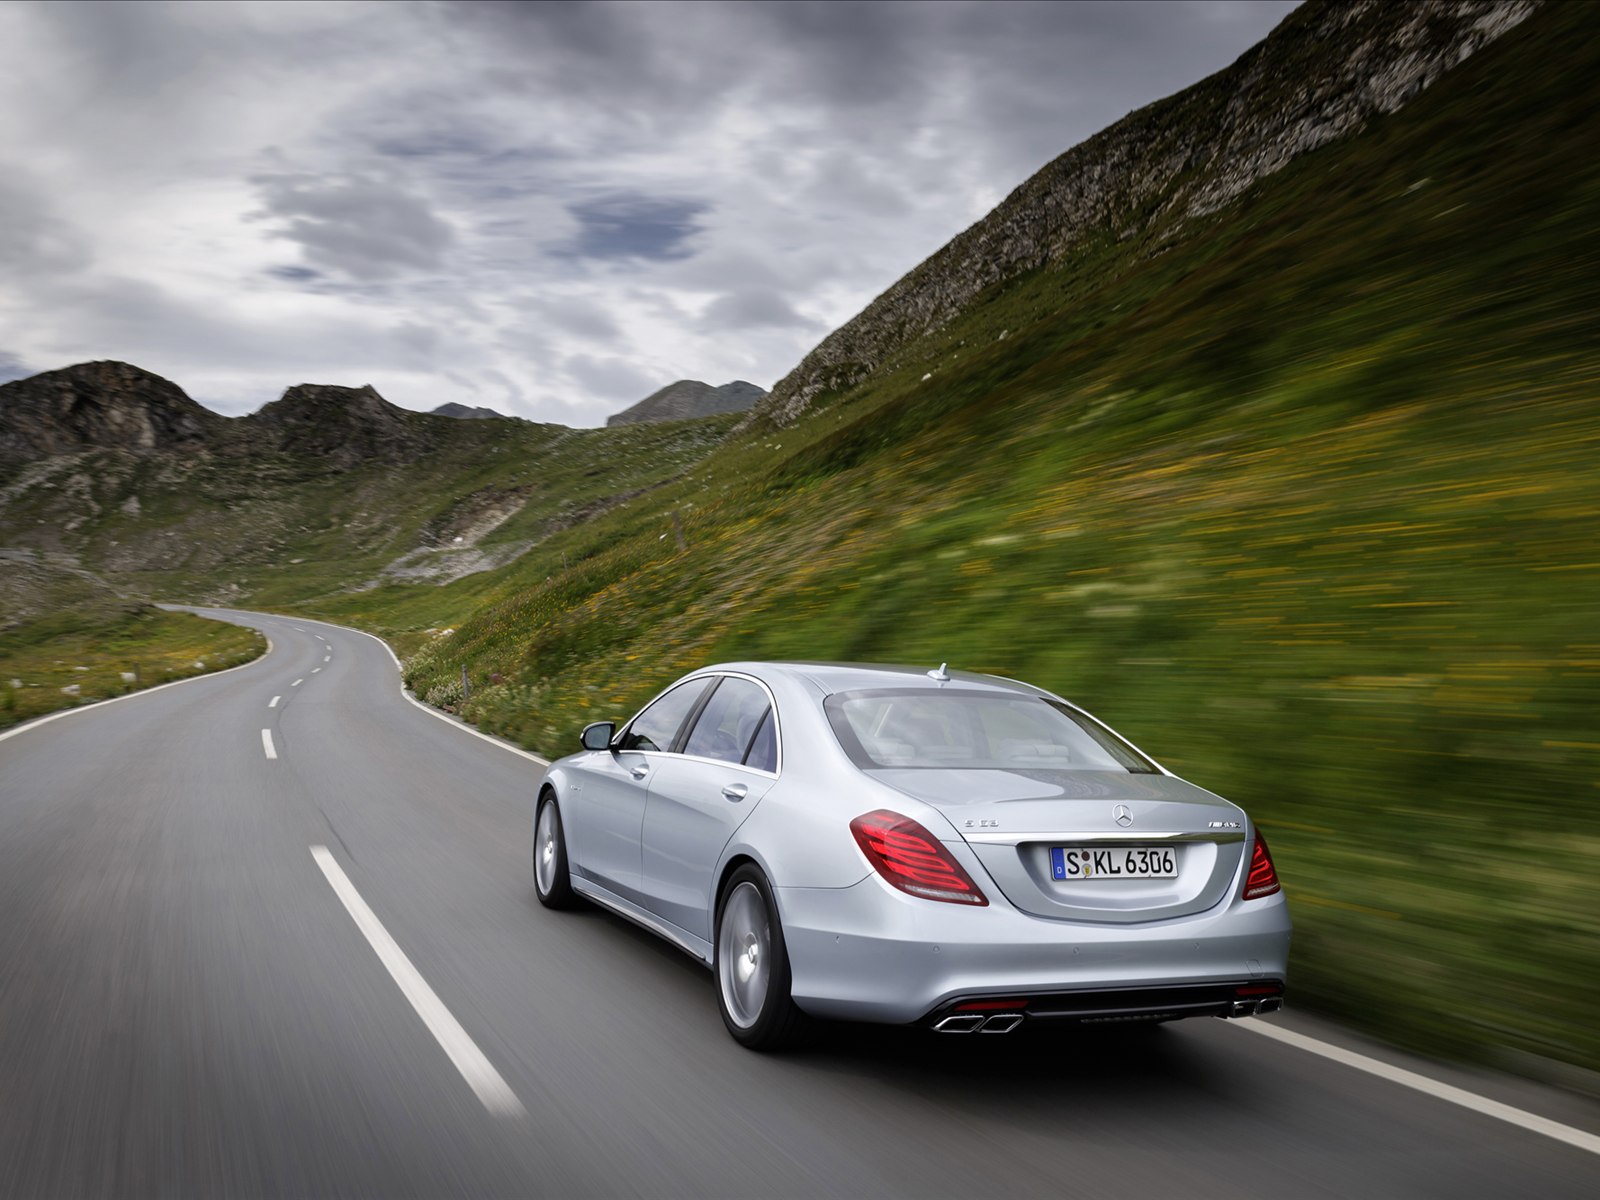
(0, 0), (1293, 426)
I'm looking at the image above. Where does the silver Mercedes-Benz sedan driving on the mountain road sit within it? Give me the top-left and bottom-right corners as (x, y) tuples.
(533, 662), (1290, 1048)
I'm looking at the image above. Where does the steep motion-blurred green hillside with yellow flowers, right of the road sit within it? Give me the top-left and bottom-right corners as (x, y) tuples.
(302, 5), (1600, 1067)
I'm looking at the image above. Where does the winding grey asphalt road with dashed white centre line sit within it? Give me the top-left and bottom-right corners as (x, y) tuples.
(0, 613), (1600, 1200)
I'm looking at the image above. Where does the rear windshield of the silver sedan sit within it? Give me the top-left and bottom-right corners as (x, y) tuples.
(822, 688), (1157, 774)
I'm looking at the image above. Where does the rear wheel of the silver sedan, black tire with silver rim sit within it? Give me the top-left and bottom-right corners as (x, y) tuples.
(712, 862), (806, 1050)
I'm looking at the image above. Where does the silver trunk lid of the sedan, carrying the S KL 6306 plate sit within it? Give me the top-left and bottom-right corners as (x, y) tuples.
(872, 768), (1250, 923)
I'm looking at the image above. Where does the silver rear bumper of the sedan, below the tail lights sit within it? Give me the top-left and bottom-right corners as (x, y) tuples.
(776, 875), (1290, 1024)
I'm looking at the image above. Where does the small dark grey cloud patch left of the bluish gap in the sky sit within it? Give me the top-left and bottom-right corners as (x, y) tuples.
(251, 174), (454, 280)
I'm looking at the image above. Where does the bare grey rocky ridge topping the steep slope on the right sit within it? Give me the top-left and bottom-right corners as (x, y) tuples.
(742, 0), (1539, 424)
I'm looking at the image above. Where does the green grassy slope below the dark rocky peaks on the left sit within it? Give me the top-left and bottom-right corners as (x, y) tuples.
(0, 414), (736, 606)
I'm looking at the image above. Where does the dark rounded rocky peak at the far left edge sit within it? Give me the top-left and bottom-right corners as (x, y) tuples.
(0, 362), (227, 461)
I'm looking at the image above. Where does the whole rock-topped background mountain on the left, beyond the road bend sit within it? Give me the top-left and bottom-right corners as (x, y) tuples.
(0, 362), (733, 601)
